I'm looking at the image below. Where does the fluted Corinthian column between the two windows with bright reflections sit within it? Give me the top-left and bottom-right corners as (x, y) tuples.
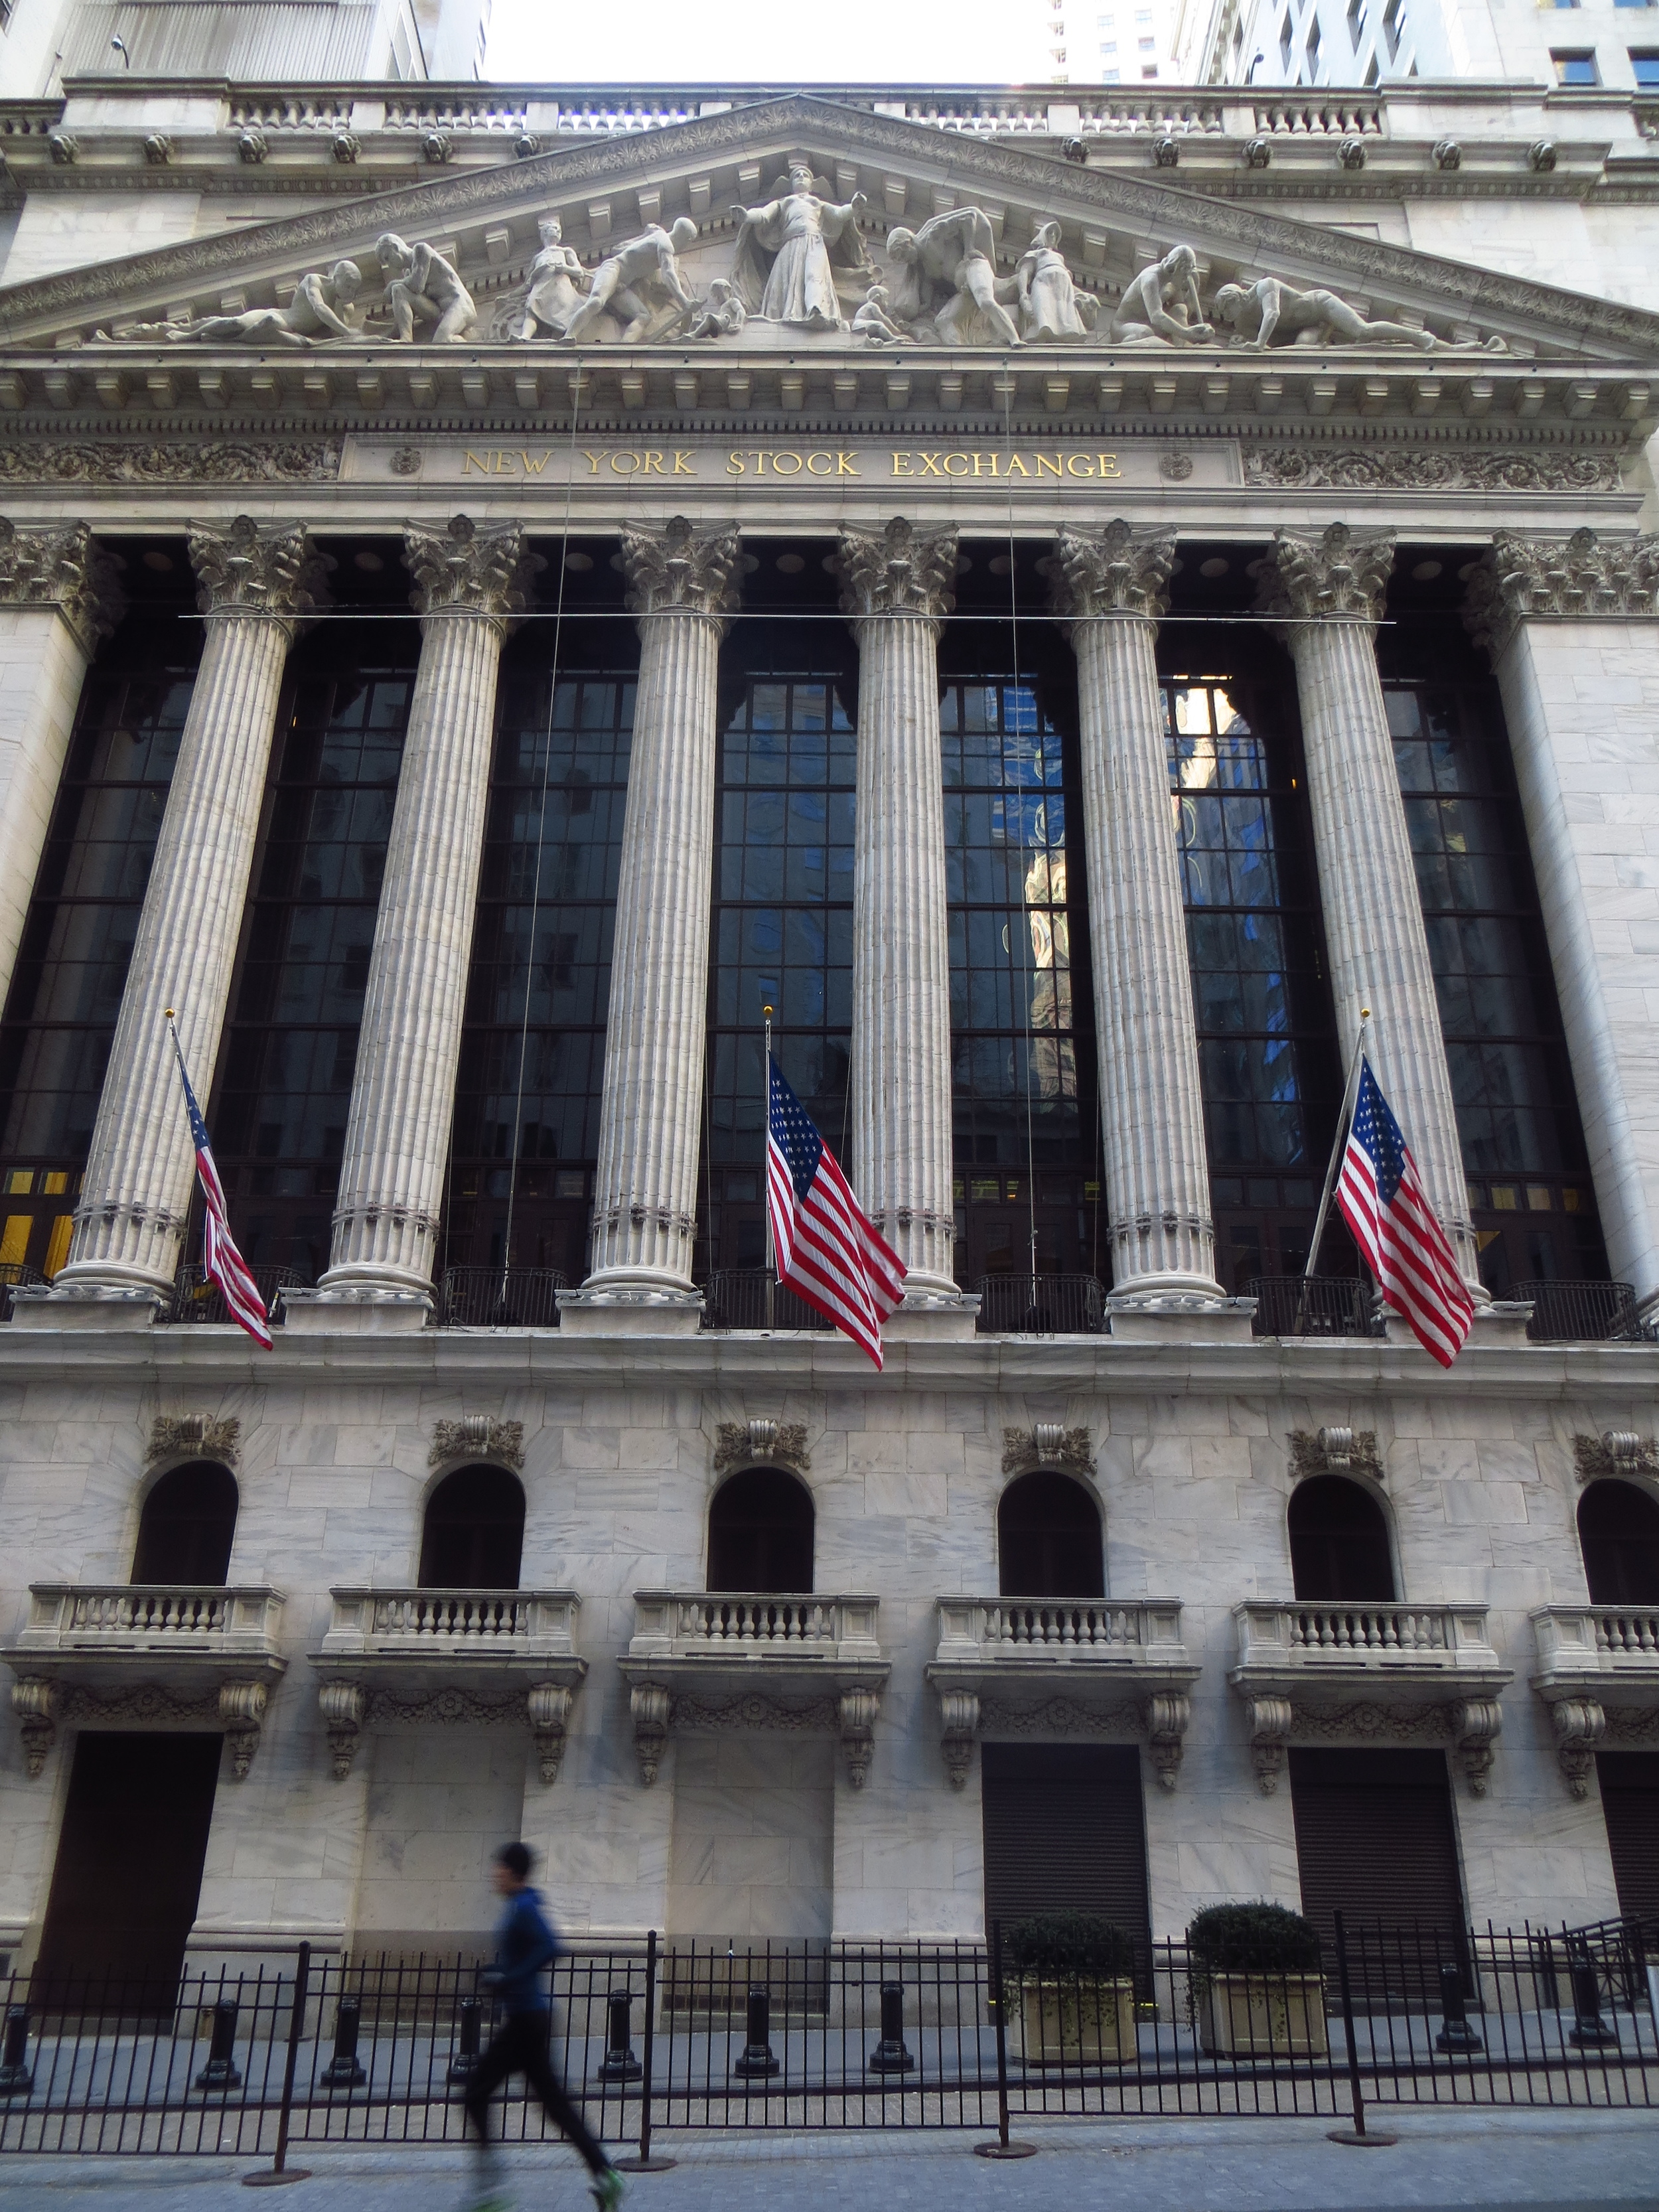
(1048, 522), (1223, 1334)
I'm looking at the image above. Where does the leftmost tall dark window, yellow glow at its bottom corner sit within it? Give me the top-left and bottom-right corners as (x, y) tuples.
(0, 632), (201, 1274)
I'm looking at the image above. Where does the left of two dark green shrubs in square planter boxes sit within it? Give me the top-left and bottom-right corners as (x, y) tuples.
(1002, 1911), (1135, 2066)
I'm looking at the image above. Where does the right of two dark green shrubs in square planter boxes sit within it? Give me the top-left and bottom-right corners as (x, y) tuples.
(1186, 1902), (1329, 2059)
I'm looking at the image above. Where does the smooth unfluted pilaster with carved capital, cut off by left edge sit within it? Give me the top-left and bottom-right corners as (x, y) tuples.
(0, 518), (121, 1002)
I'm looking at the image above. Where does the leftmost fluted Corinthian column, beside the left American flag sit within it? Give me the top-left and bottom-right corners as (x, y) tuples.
(41, 516), (330, 1321)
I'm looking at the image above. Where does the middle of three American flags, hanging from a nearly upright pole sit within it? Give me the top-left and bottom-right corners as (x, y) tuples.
(765, 1060), (904, 1367)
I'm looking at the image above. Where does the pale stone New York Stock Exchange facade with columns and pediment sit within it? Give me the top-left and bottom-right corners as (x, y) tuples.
(0, 69), (1659, 1960)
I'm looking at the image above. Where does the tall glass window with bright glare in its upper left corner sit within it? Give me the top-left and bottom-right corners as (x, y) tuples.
(1163, 677), (1336, 1291)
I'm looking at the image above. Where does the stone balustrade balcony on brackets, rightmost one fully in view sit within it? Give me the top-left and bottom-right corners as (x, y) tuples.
(1228, 1599), (1513, 1796)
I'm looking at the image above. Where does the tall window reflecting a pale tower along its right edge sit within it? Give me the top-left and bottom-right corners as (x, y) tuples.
(940, 677), (1108, 1285)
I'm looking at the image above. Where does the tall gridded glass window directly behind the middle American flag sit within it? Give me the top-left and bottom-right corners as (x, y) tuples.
(699, 663), (856, 1270)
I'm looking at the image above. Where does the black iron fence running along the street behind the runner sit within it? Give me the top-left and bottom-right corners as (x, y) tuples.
(0, 1922), (1659, 2159)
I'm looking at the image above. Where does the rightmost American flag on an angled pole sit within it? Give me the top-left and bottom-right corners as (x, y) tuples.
(1336, 1055), (1475, 1367)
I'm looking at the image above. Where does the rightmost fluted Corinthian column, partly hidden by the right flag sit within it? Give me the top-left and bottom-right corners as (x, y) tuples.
(1259, 522), (1488, 1305)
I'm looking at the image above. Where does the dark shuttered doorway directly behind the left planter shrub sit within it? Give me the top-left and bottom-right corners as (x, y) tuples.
(980, 1743), (1153, 1945)
